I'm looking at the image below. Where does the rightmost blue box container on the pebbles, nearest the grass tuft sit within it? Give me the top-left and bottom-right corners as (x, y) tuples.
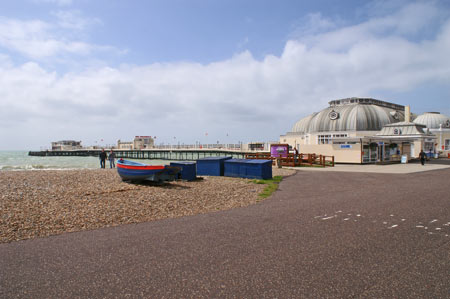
(224, 159), (272, 180)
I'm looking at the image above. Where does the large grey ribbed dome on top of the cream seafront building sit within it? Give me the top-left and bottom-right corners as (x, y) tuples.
(292, 98), (404, 133)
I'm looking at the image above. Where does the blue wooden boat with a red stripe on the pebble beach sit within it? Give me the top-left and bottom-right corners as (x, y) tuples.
(117, 159), (181, 183)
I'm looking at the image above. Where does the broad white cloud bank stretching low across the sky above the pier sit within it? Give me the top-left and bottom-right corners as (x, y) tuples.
(0, 1), (450, 148)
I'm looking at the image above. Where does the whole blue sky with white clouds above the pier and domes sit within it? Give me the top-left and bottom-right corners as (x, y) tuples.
(0, 0), (450, 150)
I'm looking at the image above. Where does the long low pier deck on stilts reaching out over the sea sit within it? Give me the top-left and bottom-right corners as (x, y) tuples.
(28, 149), (250, 161)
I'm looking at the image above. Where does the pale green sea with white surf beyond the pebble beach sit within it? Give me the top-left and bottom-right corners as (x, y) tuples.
(0, 151), (171, 171)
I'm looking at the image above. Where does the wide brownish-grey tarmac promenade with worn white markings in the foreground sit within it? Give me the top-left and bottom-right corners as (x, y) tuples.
(0, 164), (450, 298)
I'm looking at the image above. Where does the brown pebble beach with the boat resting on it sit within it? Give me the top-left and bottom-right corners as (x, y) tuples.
(0, 167), (295, 243)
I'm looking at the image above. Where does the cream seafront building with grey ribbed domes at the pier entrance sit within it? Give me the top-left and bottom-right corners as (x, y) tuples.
(280, 97), (450, 164)
